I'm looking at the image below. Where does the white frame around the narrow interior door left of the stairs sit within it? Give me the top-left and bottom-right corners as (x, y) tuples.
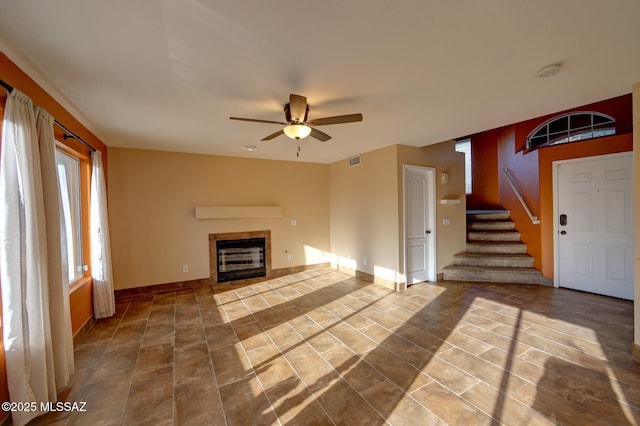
(402, 164), (437, 289)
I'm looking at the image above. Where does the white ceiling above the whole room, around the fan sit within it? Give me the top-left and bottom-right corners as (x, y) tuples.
(0, 0), (640, 163)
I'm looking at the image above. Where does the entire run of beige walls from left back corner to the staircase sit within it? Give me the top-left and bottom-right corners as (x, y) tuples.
(109, 141), (466, 289)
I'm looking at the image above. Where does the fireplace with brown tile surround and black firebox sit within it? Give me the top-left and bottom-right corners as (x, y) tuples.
(209, 231), (271, 283)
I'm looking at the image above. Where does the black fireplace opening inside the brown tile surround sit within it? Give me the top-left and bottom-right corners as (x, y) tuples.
(216, 238), (267, 282)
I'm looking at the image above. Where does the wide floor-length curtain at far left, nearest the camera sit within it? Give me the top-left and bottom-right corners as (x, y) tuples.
(0, 89), (73, 425)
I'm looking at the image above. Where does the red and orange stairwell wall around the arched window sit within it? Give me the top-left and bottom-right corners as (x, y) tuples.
(467, 94), (633, 278)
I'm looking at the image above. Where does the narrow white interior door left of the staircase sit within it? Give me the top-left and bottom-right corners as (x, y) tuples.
(404, 165), (436, 285)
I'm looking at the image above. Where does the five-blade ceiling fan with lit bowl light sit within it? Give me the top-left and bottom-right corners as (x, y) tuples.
(229, 94), (362, 155)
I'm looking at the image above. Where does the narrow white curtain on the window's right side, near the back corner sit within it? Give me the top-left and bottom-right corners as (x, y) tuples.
(91, 151), (116, 319)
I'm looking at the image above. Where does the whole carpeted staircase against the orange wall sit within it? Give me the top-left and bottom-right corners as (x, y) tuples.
(443, 210), (542, 284)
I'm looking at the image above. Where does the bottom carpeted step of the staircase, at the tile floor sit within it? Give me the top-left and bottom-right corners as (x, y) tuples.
(442, 265), (542, 284)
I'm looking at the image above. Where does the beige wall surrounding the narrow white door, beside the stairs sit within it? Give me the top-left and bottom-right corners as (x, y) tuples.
(397, 141), (467, 273)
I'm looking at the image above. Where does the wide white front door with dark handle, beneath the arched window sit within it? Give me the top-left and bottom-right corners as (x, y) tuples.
(554, 153), (633, 300)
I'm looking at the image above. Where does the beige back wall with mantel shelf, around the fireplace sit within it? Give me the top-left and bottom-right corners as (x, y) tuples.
(109, 148), (330, 289)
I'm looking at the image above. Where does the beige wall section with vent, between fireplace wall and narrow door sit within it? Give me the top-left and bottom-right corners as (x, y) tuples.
(329, 145), (399, 283)
